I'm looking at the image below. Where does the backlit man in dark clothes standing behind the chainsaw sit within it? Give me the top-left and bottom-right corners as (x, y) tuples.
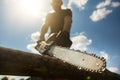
(38, 0), (72, 47)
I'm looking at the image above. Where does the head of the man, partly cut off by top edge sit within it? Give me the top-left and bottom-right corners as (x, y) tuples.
(51, 0), (63, 12)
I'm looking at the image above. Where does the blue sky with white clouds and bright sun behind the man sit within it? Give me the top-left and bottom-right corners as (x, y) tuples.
(0, 0), (120, 78)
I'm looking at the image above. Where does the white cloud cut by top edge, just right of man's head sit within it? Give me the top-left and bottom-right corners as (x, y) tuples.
(68, 0), (88, 10)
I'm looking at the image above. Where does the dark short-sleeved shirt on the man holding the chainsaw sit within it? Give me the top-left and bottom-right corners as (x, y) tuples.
(46, 9), (72, 33)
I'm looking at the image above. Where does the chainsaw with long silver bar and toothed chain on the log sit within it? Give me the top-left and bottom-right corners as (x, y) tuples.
(35, 31), (106, 73)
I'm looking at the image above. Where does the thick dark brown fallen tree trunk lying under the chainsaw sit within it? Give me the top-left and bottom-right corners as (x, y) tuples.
(0, 47), (120, 80)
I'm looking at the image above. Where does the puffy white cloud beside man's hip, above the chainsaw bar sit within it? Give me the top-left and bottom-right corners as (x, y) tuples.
(71, 33), (92, 51)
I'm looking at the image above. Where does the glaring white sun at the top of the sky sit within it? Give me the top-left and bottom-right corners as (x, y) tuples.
(20, 0), (46, 16)
